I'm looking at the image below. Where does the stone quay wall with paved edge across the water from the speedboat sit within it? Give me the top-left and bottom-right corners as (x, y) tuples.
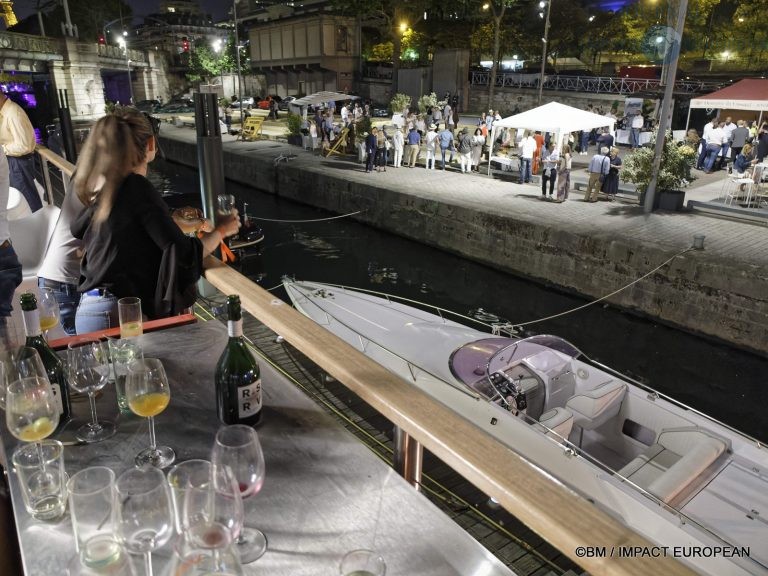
(162, 127), (768, 354)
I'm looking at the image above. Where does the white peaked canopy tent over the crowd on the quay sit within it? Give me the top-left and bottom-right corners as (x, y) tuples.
(488, 102), (616, 173)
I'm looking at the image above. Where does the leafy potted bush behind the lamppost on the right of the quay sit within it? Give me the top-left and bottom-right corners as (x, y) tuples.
(621, 131), (696, 210)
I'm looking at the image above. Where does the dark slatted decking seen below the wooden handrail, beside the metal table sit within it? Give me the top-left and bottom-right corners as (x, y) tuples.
(196, 293), (582, 576)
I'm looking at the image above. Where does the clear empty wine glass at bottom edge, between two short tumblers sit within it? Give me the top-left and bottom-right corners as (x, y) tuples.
(113, 466), (173, 576)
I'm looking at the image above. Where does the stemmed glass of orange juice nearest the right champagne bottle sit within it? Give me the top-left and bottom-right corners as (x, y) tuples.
(125, 358), (176, 468)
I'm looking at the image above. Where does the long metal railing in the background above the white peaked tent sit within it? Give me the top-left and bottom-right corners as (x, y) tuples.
(470, 72), (721, 94)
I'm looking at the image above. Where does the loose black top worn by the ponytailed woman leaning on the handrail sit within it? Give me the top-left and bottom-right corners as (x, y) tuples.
(71, 174), (203, 318)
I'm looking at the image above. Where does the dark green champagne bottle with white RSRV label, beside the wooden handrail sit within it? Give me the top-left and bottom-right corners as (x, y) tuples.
(216, 295), (261, 426)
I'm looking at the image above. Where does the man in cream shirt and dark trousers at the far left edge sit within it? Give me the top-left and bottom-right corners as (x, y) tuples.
(0, 92), (43, 212)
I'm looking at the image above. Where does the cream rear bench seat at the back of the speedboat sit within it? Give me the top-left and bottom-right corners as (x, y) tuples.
(619, 426), (730, 504)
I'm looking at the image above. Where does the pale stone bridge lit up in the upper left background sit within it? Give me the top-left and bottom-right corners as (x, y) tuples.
(0, 31), (167, 122)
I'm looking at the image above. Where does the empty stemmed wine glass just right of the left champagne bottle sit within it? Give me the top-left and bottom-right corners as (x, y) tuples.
(67, 338), (116, 443)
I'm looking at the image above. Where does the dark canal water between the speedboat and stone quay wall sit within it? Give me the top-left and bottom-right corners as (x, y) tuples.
(153, 162), (768, 441)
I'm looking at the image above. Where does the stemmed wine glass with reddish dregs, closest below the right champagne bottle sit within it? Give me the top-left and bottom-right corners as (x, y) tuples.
(211, 424), (267, 564)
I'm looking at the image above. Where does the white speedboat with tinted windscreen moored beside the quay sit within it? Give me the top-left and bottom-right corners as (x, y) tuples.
(284, 279), (768, 576)
